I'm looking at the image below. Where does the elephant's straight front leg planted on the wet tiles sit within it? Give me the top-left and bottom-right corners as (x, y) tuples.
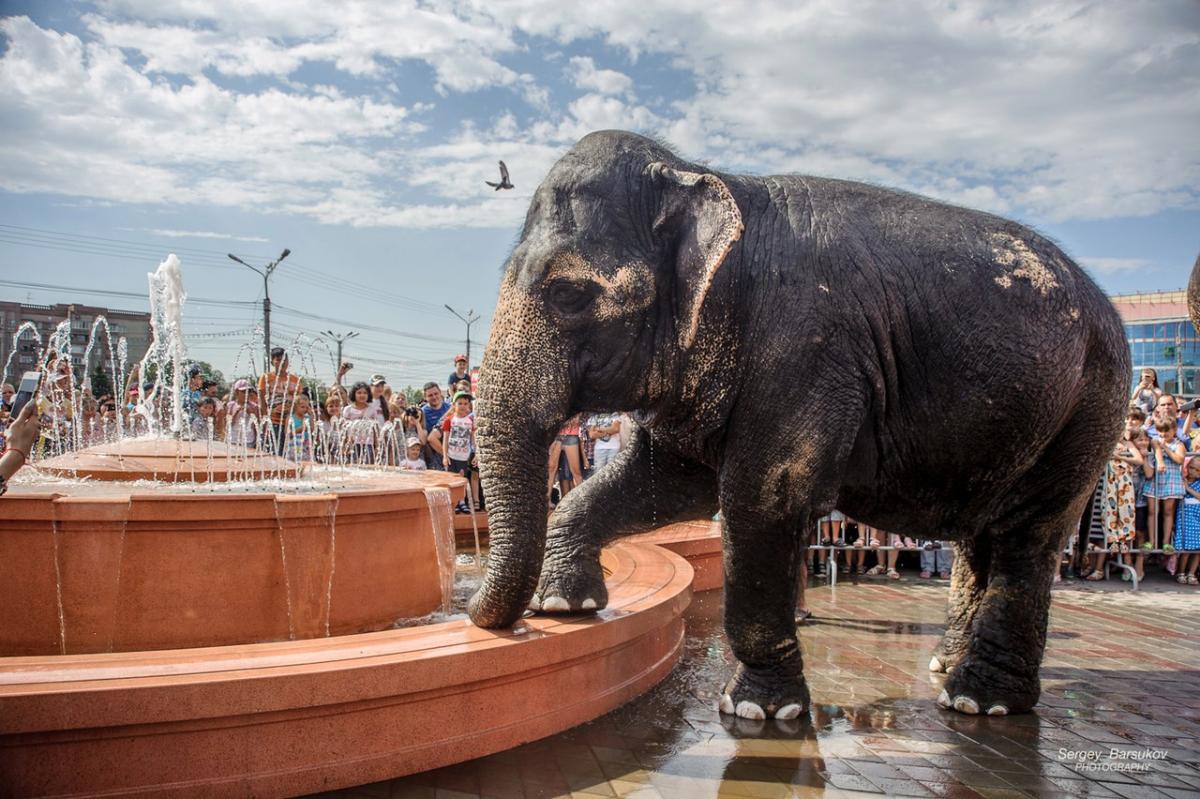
(720, 504), (809, 719)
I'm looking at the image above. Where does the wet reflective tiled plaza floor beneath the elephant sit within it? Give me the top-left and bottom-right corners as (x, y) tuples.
(312, 568), (1200, 799)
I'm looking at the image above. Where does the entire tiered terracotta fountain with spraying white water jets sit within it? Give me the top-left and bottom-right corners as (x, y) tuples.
(0, 256), (692, 795)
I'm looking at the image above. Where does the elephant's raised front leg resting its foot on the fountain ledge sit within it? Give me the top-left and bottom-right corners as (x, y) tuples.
(529, 428), (716, 613)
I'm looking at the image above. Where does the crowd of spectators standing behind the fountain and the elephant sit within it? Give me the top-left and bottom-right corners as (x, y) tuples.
(0, 348), (1200, 585)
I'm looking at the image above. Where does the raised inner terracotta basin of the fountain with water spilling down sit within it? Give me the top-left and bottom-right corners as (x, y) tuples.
(0, 436), (466, 656)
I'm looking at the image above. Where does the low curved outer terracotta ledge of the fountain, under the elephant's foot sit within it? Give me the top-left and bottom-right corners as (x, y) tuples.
(0, 543), (692, 797)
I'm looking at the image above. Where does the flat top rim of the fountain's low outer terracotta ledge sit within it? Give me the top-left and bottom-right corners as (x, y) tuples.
(0, 542), (692, 719)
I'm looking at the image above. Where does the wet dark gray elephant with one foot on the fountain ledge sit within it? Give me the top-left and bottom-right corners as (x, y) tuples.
(469, 132), (1130, 719)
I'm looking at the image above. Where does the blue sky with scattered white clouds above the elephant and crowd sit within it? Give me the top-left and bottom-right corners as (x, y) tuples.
(0, 0), (1200, 385)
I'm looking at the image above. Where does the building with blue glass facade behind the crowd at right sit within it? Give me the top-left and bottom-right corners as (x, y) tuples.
(1110, 292), (1200, 400)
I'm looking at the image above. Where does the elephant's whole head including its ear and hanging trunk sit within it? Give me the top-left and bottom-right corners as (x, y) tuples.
(469, 132), (743, 627)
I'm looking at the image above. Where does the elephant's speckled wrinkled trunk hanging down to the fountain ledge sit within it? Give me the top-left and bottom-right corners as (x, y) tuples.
(467, 281), (568, 627)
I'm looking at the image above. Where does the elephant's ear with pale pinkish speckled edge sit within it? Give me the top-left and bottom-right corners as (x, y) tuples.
(648, 162), (744, 349)
